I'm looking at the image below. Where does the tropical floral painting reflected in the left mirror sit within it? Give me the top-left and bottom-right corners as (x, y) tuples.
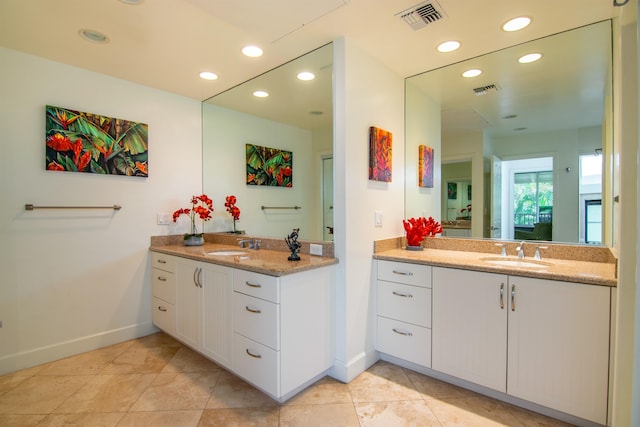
(246, 144), (293, 187)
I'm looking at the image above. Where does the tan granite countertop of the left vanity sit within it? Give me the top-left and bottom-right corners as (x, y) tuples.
(149, 242), (338, 277)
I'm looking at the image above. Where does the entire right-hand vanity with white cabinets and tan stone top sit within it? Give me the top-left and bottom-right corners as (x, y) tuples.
(374, 239), (617, 425)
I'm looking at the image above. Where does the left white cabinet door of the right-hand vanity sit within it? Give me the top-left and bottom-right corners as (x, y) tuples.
(431, 267), (508, 392)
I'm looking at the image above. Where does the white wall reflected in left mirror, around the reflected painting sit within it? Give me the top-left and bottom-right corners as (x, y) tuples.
(203, 103), (322, 240)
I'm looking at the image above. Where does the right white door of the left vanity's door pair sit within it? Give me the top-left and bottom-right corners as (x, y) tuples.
(200, 264), (233, 367)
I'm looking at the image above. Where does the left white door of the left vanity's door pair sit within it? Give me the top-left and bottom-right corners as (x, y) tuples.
(176, 258), (203, 349)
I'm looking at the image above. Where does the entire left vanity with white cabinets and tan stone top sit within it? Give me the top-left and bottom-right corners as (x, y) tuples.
(151, 236), (337, 402)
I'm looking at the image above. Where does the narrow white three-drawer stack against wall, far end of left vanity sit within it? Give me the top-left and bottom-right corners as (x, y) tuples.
(151, 252), (176, 335)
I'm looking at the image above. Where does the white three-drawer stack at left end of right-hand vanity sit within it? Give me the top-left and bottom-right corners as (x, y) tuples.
(376, 260), (431, 367)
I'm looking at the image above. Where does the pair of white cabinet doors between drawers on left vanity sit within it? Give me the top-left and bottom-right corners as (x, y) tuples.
(171, 257), (233, 368)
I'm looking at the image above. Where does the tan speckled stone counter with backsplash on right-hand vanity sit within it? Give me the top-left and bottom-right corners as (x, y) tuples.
(373, 238), (618, 286)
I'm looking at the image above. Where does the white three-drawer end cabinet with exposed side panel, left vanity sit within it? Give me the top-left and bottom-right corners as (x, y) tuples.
(233, 267), (333, 401)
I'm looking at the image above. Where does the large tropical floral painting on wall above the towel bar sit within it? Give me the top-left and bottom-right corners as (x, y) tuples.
(46, 105), (149, 177)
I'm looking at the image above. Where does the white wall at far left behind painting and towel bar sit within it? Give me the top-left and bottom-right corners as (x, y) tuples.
(0, 48), (202, 374)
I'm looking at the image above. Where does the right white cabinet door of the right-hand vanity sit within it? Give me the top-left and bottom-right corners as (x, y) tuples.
(507, 277), (611, 424)
